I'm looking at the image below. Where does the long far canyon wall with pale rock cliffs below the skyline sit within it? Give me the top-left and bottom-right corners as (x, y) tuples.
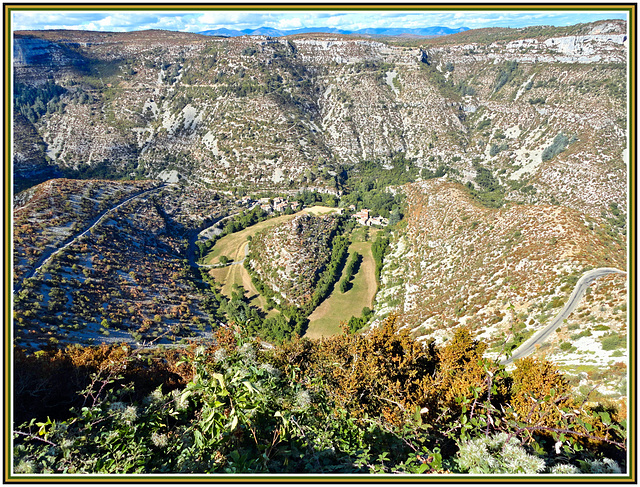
(14, 21), (627, 216)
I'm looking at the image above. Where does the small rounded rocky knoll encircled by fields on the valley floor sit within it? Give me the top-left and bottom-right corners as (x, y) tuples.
(249, 214), (337, 306)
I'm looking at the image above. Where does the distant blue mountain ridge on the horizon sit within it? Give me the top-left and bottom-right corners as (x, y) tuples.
(198, 26), (469, 37)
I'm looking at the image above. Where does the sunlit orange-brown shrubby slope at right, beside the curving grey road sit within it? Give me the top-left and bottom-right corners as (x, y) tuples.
(376, 179), (626, 370)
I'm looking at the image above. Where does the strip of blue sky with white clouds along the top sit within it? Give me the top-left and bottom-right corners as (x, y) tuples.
(12, 6), (626, 32)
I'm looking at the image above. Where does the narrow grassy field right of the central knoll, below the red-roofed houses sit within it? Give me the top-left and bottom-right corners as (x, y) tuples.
(305, 227), (377, 338)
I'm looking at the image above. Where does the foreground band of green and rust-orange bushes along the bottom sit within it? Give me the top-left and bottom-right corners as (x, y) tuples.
(13, 316), (626, 476)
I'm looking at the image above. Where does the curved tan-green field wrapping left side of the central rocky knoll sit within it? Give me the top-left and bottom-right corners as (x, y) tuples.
(204, 206), (335, 316)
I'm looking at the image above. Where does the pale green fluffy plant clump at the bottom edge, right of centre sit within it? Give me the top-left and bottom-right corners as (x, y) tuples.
(457, 433), (545, 475)
